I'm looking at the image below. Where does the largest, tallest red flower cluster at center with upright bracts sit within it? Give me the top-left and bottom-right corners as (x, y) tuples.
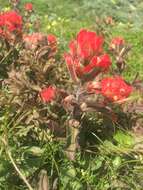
(64, 30), (111, 80)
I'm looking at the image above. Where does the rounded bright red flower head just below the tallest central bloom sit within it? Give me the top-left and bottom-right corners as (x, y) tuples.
(101, 76), (133, 101)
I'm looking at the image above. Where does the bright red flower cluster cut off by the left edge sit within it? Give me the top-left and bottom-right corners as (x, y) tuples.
(0, 11), (22, 39)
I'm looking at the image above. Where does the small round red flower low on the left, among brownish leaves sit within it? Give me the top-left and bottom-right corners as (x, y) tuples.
(40, 86), (56, 102)
